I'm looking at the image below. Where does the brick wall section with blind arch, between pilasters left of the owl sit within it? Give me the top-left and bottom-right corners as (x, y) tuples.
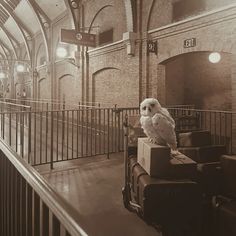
(88, 43), (139, 107)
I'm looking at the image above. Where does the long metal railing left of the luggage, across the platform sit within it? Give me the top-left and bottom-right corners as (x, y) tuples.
(0, 107), (123, 167)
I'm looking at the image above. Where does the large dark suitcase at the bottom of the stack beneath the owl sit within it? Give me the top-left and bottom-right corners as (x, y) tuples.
(137, 174), (201, 236)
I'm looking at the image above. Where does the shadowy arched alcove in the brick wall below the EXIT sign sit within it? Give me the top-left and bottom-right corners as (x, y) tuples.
(162, 51), (232, 110)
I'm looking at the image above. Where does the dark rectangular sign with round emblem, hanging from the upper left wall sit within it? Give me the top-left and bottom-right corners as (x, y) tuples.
(61, 29), (96, 47)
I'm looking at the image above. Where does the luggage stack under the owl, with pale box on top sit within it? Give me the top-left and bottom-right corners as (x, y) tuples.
(128, 138), (202, 236)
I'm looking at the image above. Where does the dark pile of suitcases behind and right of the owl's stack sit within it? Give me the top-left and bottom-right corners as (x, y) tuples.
(178, 130), (226, 235)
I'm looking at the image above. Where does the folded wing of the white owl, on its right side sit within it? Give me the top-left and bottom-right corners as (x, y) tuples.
(152, 113), (177, 149)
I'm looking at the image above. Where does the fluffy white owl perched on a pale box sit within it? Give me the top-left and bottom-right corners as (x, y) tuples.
(140, 98), (179, 155)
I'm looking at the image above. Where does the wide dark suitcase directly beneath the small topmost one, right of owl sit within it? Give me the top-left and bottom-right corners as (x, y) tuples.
(178, 145), (226, 163)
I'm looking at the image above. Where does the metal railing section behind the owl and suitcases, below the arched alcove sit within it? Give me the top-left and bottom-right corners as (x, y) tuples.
(118, 105), (236, 154)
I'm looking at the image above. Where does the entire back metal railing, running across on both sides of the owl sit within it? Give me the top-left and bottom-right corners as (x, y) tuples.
(0, 103), (233, 167)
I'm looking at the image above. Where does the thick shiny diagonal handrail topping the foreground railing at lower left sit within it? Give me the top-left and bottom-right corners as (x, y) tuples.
(0, 138), (87, 236)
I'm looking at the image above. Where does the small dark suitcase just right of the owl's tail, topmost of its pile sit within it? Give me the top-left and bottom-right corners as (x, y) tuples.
(178, 130), (211, 147)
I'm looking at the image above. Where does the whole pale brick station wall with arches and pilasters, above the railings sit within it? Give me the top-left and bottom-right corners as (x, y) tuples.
(6, 0), (236, 111)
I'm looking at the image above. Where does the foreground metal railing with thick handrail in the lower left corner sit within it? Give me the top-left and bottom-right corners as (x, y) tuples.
(0, 140), (87, 236)
